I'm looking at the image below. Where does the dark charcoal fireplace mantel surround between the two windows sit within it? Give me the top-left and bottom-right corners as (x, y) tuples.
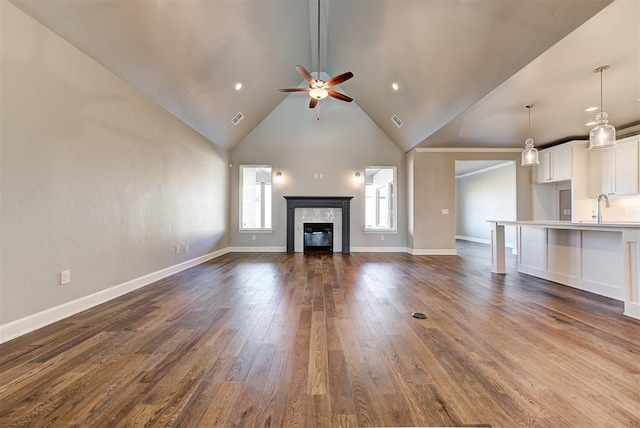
(284, 196), (353, 254)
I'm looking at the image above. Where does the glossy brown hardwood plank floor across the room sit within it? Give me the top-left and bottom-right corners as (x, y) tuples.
(0, 242), (640, 427)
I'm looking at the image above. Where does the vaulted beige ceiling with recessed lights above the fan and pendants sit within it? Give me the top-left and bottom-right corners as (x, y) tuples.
(12, 0), (640, 150)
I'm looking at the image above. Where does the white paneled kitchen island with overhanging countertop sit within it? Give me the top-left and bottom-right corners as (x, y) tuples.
(489, 220), (640, 319)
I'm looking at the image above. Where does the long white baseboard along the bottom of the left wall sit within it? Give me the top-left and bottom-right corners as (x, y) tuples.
(0, 248), (229, 343)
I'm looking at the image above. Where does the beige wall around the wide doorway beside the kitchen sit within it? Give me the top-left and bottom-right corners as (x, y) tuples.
(407, 150), (531, 251)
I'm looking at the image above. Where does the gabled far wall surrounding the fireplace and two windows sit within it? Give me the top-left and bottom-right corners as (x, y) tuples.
(230, 79), (407, 251)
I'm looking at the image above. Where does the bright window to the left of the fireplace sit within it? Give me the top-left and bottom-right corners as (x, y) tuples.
(240, 165), (271, 229)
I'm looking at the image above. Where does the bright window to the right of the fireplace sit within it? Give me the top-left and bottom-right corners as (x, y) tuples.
(364, 166), (397, 230)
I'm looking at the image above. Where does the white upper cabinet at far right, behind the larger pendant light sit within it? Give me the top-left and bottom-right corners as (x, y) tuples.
(589, 136), (640, 198)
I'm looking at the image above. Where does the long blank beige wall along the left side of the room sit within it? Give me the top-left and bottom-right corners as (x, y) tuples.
(0, 0), (228, 341)
